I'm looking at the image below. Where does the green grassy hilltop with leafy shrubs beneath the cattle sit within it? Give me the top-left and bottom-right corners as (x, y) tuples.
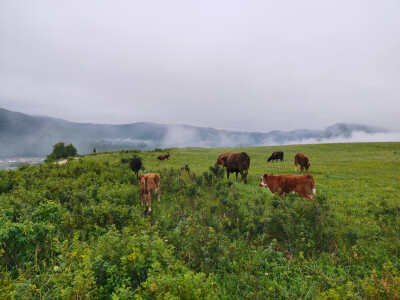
(0, 143), (400, 299)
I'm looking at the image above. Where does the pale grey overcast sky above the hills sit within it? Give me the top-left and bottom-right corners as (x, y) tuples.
(0, 0), (400, 132)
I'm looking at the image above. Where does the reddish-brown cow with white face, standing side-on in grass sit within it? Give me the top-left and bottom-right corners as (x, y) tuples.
(260, 174), (315, 200)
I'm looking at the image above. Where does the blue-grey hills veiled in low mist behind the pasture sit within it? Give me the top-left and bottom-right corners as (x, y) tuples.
(0, 108), (385, 158)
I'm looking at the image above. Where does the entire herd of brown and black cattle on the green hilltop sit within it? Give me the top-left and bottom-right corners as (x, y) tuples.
(130, 151), (315, 212)
